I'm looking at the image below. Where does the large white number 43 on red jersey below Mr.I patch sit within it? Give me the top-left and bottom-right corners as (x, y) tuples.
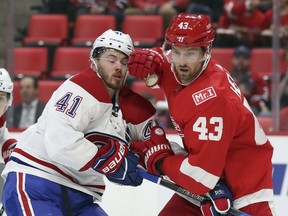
(193, 117), (223, 141)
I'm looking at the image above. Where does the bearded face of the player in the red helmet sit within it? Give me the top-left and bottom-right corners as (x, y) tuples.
(171, 46), (204, 84)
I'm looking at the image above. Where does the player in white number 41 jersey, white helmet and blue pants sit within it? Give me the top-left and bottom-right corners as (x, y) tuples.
(2, 30), (156, 216)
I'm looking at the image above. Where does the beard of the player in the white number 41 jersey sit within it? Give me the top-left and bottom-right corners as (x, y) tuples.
(98, 64), (127, 91)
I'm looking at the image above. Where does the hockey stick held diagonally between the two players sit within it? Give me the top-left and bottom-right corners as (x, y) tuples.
(138, 168), (251, 216)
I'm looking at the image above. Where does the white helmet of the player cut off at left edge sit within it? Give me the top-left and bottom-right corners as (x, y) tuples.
(0, 68), (14, 106)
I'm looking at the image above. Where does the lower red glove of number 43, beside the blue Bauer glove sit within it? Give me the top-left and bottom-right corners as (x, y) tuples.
(130, 126), (174, 175)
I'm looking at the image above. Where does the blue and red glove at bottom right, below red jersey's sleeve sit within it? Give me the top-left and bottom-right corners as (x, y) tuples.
(200, 179), (232, 216)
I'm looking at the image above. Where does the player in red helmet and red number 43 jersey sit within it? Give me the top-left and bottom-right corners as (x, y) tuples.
(129, 14), (274, 216)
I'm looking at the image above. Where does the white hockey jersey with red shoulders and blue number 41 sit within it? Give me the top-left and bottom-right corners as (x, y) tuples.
(2, 69), (156, 200)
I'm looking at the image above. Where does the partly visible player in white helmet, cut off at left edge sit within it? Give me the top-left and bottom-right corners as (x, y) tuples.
(0, 68), (17, 164)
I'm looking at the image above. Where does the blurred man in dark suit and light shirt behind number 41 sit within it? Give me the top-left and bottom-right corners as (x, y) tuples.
(13, 76), (46, 129)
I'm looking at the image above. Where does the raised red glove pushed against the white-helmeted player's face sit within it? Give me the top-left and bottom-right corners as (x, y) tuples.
(128, 49), (164, 79)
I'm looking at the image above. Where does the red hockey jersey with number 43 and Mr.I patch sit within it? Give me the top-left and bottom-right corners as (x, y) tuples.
(152, 49), (273, 208)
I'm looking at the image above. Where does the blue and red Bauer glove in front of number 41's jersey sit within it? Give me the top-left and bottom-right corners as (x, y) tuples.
(92, 140), (143, 186)
